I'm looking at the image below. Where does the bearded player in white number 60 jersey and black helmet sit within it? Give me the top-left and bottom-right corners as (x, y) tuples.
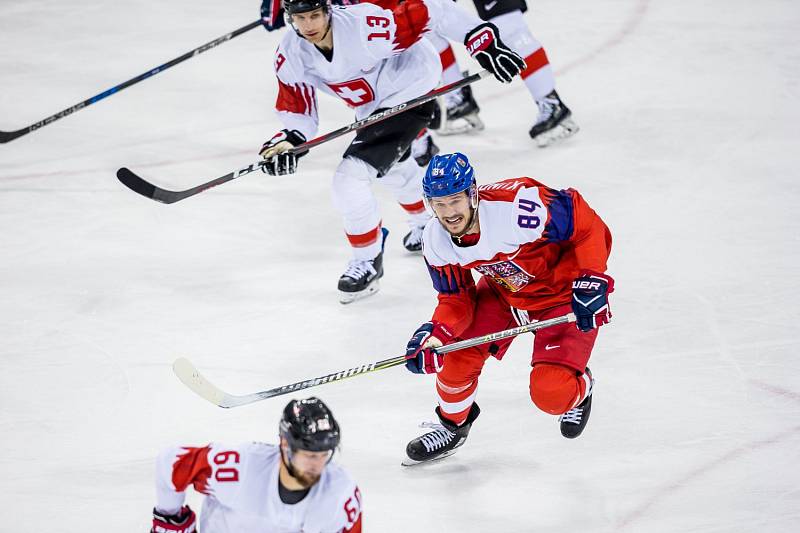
(151, 398), (361, 533)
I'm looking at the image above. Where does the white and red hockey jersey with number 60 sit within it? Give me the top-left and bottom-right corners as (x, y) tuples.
(156, 442), (361, 533)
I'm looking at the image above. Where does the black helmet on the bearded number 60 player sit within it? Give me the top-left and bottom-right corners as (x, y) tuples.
(280, 396), (341, 452)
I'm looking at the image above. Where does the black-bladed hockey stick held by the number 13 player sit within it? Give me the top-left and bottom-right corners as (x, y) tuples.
(117, 70), (489, 204)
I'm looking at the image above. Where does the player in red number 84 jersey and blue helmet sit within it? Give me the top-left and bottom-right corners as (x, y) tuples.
(404, 153), (614, 464)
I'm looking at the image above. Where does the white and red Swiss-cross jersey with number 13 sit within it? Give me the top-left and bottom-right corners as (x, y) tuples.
(275, 0), (482, 139)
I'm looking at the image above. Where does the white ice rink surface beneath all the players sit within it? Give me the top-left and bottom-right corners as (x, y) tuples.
(0, 0), (800, 533)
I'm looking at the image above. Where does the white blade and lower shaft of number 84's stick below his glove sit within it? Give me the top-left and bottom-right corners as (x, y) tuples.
(172, 356), (406, 409)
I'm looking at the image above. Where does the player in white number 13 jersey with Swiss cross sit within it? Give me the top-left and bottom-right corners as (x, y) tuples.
(261, 0), (525, 303)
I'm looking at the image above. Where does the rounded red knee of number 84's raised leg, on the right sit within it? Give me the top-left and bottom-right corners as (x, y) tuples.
(530, 363), (582, 415)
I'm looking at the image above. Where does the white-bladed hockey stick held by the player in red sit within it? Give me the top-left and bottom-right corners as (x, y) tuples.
(172, 313), (575, 409)
